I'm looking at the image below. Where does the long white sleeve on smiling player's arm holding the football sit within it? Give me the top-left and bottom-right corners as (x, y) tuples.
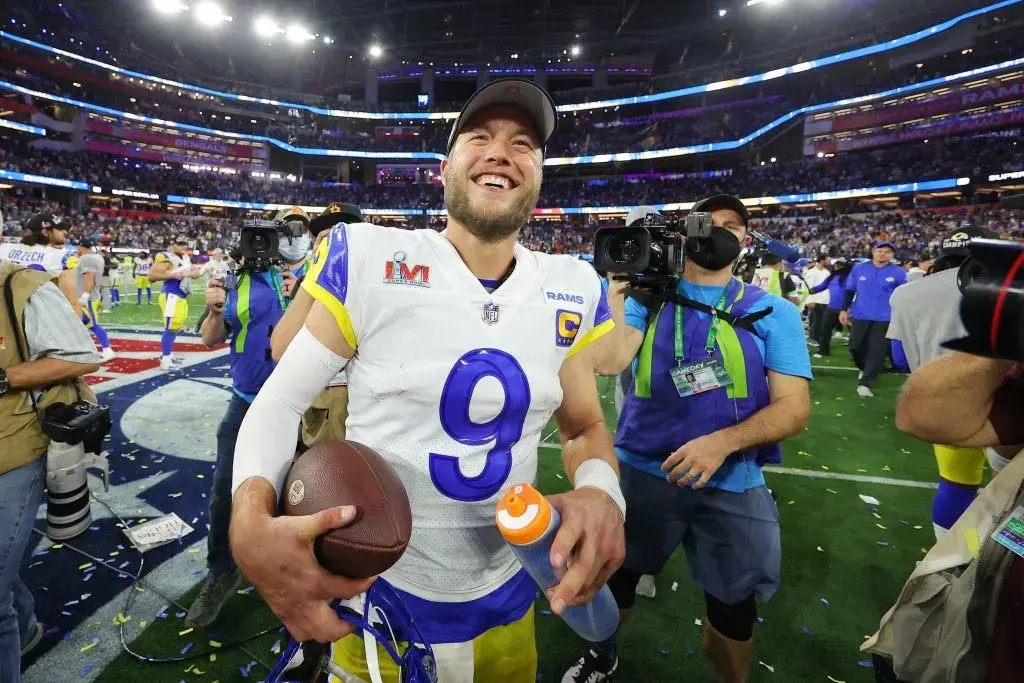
(231, 326), (348, 500)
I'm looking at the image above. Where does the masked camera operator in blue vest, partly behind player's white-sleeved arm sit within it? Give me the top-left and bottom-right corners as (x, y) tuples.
(187, 209), (310, 628)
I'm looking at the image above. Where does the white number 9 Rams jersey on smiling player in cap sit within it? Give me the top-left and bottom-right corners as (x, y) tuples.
(303, 223), (612, 602)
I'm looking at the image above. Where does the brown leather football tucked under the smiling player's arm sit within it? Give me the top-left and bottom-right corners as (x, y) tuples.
(282, 441), (413, 579)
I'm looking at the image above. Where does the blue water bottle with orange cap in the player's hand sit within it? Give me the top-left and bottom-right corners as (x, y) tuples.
(496, 483), (618, 642)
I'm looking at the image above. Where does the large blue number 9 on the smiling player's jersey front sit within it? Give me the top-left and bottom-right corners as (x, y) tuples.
(430, 348), (529, 502)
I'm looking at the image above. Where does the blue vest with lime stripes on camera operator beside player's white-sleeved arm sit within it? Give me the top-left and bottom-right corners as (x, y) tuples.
(224, 270), (285, 396)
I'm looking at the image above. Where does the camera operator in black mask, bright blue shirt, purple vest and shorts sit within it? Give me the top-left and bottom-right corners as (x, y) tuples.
(562, 195), (811, 683)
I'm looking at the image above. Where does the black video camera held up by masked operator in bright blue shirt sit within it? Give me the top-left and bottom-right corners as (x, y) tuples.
(594, 211), (714, 288)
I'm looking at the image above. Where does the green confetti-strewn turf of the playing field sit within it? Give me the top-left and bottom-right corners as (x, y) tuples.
(100, 344), (936, 683)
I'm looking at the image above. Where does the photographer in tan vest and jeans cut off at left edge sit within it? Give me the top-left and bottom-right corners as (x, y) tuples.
(0, 259), (100, 683)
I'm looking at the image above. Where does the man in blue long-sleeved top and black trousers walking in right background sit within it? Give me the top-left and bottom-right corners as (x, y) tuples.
(839, 242), (906, 398)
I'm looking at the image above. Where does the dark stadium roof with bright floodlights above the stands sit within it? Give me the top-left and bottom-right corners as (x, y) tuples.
(22, 0), (991, 93)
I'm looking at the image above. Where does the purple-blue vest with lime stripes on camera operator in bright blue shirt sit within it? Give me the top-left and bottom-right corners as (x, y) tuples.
(615, 279), (782, 476)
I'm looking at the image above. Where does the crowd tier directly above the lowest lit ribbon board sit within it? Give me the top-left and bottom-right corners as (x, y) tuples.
(0, 130), (1024, 209)
